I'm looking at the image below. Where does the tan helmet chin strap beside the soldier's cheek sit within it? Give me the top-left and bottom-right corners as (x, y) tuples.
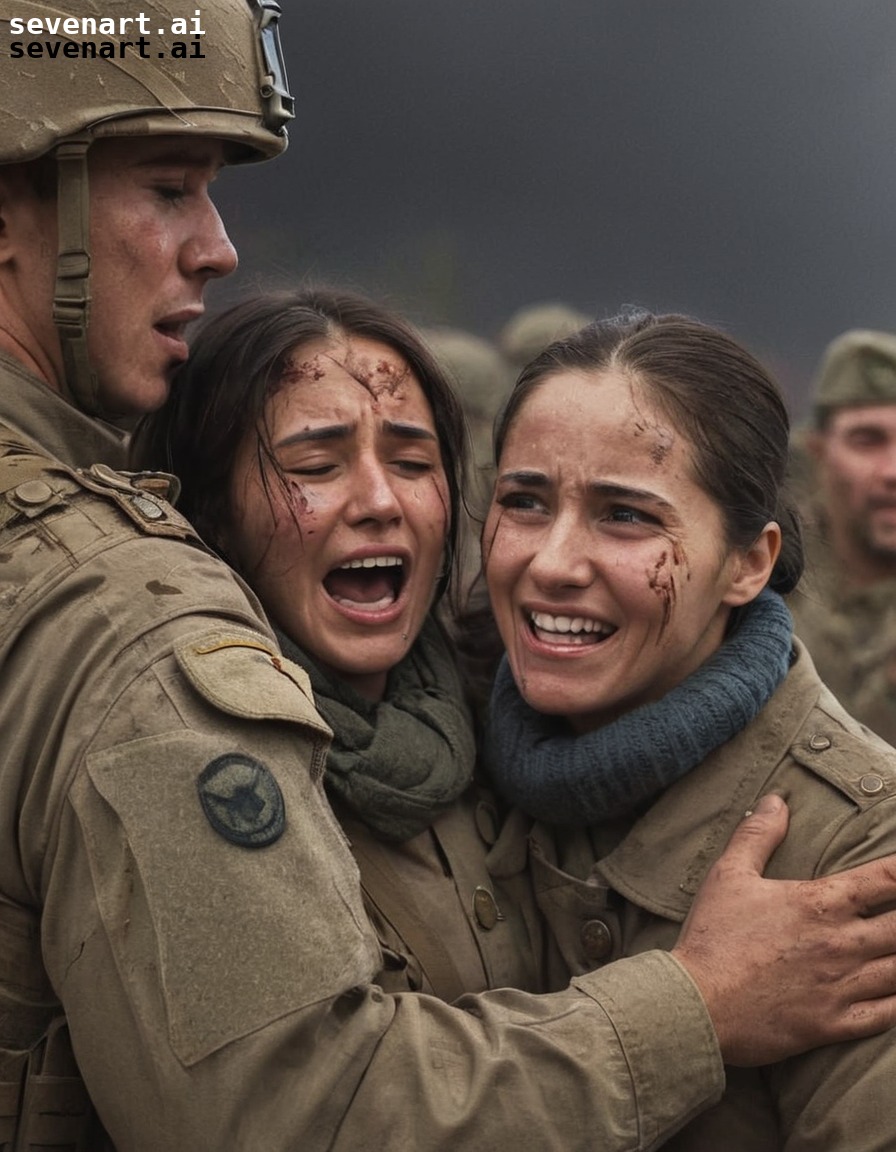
(53, 136), (100, 416)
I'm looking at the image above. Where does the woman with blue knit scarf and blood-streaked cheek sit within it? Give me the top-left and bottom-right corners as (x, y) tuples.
(483, 313), (896, 1152)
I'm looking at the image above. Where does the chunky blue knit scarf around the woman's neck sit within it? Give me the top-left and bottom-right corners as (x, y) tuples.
(486, 589), (794, 826)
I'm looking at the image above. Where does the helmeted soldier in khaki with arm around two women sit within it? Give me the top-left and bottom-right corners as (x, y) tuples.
(0, 0), (896, 1152)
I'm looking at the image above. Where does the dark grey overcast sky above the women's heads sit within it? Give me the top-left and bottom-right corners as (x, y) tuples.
(215, 0), (896, 415)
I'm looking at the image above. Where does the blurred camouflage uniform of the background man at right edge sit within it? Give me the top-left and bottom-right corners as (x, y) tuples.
(789, 526), (896, 745)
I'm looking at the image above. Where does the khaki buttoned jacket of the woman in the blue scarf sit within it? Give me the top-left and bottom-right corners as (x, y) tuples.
(531, 645), (896, 1152)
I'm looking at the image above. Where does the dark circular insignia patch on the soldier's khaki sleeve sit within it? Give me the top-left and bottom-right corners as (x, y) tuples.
(196, 752), (287, 848)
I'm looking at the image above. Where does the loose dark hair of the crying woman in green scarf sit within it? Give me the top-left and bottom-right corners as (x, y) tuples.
(132, 288), (466, 594)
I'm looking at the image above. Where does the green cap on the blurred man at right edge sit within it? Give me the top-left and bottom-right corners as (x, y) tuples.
(813, 328), (896, 427)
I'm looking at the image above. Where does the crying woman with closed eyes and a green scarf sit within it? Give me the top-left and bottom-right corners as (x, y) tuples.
(131, 290), (539, 1001)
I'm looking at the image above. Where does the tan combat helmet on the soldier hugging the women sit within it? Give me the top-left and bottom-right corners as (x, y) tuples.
(0, 0), (287, 164)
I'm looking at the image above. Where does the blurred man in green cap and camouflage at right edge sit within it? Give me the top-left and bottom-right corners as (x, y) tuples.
(792, 329), (896, 744)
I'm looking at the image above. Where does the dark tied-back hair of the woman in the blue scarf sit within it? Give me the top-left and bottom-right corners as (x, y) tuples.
(495, 311), (804, 593)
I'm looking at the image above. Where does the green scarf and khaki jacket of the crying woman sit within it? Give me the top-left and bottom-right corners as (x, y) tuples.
(276, 617), (544, 1001)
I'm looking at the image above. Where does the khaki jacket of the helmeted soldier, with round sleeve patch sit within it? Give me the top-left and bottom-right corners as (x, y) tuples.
(0, 358), (722, 1152)
